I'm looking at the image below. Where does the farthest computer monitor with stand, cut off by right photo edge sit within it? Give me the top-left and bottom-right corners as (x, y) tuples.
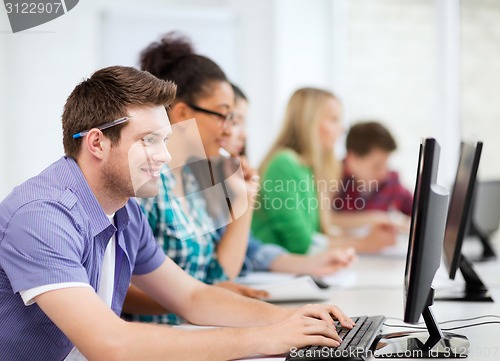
(468, 180), (500, 262)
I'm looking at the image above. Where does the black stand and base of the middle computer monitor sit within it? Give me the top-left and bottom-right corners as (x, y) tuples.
(436, 255), (494, 302)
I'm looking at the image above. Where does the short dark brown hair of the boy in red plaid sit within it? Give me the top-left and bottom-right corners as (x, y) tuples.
(346, 121), (397, 157)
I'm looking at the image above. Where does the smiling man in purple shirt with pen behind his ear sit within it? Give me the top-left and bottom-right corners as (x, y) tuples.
(0, 66), (353, 361)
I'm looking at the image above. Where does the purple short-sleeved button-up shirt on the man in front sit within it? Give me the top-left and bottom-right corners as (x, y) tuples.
(0, 157), (165, 361)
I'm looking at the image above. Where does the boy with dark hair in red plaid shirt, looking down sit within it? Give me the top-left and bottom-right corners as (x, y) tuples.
(333, 121), (413, 227)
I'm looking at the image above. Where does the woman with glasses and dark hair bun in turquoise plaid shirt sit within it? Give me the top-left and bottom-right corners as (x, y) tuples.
(124, 33), (266, 323)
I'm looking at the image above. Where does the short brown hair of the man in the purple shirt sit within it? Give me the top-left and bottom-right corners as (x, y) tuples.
(62, 66), (176, 158)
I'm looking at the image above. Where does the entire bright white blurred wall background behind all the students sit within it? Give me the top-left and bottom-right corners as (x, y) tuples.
(0, 0), (500, 199)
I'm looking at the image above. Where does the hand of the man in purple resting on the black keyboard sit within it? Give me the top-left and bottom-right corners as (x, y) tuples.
(254, 305), (354, 354)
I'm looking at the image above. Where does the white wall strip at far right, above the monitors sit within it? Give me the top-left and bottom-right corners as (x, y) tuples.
(461, 0), (500, 179)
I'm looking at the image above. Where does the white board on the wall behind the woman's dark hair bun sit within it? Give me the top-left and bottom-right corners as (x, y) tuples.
(102, 6), (237, 78)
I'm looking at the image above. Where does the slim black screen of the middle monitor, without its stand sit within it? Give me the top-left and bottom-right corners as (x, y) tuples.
(444, 142), (483, 279)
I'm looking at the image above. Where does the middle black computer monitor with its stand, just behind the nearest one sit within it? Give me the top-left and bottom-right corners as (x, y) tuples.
(436, 142), (493, 302)
